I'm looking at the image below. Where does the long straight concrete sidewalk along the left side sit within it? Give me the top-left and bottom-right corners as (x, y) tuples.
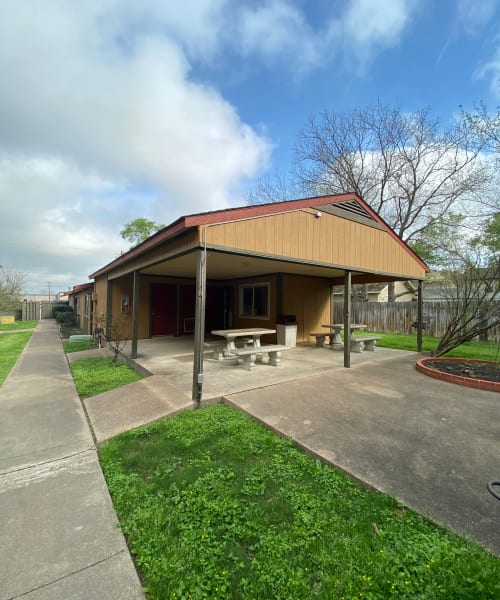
(0, 320), (144, 600)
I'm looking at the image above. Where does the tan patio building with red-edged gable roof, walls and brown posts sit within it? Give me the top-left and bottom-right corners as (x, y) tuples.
(91, 194), (428, 404)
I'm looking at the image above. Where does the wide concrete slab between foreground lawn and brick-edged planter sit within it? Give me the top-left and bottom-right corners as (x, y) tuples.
(225, 354), (500, 556)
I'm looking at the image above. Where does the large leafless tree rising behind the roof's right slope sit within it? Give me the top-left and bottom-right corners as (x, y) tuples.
(295, 103), (491, 301)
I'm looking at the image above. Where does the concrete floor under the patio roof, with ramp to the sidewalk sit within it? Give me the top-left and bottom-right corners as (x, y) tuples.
(84, 336), (415, 443)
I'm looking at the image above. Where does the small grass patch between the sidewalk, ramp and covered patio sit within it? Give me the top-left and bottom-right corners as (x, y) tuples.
(70, 358), (142, 400)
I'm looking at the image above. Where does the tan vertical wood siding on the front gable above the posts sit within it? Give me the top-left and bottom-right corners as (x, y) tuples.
(206, 212), (425, 279)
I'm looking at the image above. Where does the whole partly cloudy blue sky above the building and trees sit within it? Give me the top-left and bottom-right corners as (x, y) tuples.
(0, 0), (500, 293)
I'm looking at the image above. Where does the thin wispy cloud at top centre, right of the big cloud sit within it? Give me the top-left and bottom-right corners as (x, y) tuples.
(233, 0), (420, 77)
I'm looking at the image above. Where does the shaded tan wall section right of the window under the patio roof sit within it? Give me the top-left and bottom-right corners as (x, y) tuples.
(283, 276), (331, 342)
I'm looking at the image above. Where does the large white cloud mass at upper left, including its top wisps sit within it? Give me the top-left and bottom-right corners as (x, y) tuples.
(0, 0), (424, 290)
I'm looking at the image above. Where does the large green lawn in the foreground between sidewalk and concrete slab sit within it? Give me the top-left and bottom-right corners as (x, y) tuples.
(100, 405), (500, 600)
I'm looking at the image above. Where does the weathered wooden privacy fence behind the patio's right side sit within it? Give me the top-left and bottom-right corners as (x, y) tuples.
(333, 302), (500, 341)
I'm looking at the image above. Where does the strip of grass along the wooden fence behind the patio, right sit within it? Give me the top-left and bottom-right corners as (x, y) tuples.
(364, 331), (499, 361)
